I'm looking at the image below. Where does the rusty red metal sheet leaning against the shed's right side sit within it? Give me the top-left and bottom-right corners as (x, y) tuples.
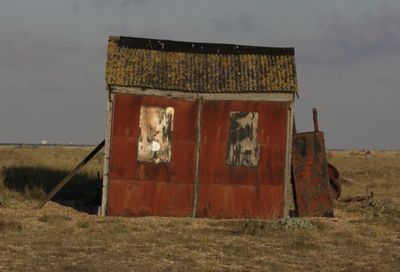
(292, 132), (333, 217)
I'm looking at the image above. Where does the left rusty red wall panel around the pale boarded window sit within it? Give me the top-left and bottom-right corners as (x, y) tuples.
(107, 94), (197, 216)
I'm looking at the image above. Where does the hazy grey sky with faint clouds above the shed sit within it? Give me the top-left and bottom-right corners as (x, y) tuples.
(0, 0), (400, 149)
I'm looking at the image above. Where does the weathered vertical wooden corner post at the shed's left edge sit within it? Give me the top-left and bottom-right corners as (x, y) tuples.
(100, 91), (114, 216)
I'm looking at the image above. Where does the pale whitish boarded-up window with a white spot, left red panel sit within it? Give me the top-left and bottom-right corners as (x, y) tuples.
(138, 106), (174, 163)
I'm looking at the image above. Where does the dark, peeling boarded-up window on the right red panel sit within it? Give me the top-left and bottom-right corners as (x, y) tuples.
(226, 111), (259, 167)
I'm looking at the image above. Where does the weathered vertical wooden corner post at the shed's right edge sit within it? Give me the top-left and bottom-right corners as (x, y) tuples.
(284, 102), (294, 217)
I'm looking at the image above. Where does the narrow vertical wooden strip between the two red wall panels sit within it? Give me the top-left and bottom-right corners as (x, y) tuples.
(192, 98), (203, 218)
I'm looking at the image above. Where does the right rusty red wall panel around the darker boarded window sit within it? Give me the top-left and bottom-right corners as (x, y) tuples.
(197, 101), (288, 218)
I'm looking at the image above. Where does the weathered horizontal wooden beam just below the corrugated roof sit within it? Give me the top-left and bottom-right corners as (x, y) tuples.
(111, 86), (295, 102)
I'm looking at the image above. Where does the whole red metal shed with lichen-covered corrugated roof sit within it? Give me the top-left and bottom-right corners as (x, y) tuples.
(101, 37), (297, 218)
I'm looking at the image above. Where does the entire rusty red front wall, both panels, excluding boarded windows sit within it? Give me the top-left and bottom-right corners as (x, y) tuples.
(107, 94), (288, 218)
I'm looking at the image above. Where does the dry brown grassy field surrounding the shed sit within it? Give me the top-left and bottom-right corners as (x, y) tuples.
(0, 146), (400, 271)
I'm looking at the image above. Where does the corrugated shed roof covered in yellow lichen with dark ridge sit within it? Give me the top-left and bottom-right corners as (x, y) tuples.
(106, 37), (297, 93)
